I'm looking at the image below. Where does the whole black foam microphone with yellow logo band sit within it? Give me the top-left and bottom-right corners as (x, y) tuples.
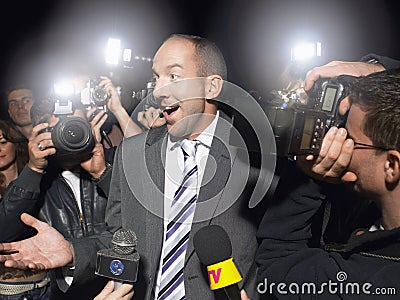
(193, 225), (242, 300)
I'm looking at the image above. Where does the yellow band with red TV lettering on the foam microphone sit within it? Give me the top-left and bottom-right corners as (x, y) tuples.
(207, 258), (242, 290)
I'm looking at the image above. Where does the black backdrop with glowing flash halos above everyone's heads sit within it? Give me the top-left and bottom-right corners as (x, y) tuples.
(0, 0), (400, 119)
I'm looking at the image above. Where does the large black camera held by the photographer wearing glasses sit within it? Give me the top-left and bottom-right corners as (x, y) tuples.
(263, 75), (356, 158)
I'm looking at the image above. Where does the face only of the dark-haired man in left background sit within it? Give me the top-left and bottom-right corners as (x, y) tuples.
(7, 89), (35, 127)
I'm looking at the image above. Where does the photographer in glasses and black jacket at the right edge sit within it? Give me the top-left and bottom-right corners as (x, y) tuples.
(256, 71), (400, 299)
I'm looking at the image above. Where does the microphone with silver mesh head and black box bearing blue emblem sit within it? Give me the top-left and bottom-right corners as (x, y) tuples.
(95, 228), (140, 290)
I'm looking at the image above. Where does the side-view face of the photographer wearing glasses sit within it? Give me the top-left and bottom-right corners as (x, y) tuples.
(346, 105), (387, 197)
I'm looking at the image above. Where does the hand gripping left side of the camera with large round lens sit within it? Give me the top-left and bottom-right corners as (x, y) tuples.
(28, 123), (56, 173)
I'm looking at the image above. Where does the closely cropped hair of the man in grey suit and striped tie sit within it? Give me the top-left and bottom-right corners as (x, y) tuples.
(166, 34), (228, 80)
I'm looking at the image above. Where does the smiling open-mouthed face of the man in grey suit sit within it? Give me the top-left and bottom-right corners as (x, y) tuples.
(153, 38), (216, 138)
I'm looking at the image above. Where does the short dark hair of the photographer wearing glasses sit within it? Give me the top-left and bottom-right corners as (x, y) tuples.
(350, 71), (400, 150)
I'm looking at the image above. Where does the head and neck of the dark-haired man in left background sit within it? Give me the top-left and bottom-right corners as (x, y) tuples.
(6, 85), (35, 139)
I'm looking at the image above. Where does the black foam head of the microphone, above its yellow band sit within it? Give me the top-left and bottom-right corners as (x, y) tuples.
(193, 225), (232, 266)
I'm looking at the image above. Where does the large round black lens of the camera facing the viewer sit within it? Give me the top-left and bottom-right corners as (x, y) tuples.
(51, 117), (94, 154)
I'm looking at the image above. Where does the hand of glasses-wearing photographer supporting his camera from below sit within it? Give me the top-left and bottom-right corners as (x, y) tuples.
(297, 127), (357, 183)
